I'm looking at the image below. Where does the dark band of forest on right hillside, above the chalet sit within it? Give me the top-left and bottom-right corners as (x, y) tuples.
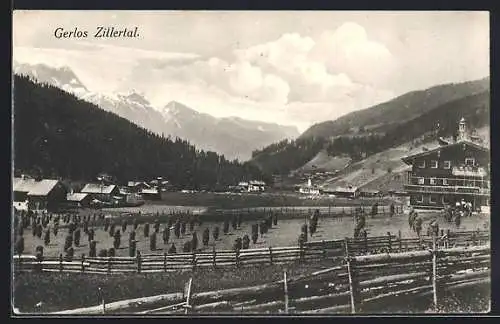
(253, 85), (490, 174)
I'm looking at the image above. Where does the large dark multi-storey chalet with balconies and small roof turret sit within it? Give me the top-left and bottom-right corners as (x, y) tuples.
(402, 118), (490, 210)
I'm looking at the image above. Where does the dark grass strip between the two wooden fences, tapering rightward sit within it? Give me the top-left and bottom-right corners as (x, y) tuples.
(14, 260), (332, 312)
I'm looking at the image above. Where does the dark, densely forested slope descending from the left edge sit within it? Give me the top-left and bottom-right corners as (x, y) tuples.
(14, 75), (267, 189)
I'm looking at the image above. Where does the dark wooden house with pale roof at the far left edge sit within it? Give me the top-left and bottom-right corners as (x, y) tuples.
(13, 177), (67, 211)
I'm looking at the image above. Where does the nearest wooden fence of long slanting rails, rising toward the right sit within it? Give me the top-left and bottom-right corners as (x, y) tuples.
(48, 245), (490, 314)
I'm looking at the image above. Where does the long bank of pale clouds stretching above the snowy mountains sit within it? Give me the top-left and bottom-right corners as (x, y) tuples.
(14, 23), (394, 129)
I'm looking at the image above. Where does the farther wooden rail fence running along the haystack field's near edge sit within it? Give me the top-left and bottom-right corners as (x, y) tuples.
(14, 231), (489, 274)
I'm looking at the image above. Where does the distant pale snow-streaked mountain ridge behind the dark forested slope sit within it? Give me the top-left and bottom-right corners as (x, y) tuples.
(14, 63), (300, 161)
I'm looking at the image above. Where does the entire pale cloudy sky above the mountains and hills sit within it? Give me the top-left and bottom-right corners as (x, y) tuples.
(13, 11), (489, 131)
